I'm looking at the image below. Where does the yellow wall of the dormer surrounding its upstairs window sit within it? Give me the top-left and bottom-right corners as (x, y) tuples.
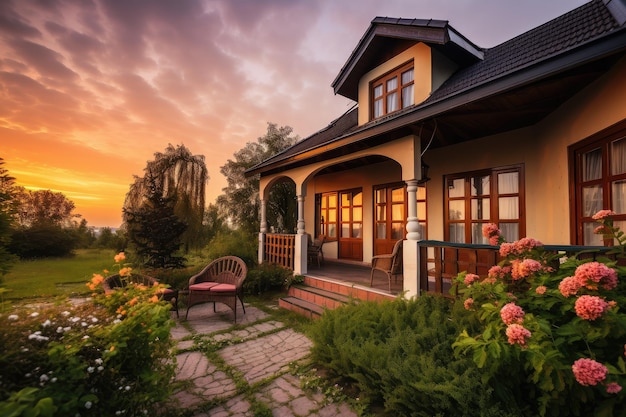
(359, 43), (432, 125)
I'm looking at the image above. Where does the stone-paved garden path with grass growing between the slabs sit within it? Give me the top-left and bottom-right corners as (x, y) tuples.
(172, 304), (357, 417)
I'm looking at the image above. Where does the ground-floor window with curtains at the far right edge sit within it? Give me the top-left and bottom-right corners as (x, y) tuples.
(570, 124), (626, 246)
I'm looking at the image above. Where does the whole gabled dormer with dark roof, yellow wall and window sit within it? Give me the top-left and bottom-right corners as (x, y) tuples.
(332, 17), (483, 125)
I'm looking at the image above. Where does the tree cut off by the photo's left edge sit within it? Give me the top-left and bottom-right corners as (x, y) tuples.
(0, 158), (16, 277)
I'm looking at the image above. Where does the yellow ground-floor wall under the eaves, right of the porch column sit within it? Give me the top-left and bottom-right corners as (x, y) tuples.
(424, 55), (626, 244)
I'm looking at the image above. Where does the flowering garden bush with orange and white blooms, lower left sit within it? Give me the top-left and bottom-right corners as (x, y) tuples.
(0, 254), (176, 416)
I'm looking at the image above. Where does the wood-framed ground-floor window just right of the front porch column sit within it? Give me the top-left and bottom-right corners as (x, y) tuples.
(445, 165), (526, 244)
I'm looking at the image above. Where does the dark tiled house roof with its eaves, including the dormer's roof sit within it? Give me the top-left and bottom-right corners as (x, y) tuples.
(247, 0), (626, 175)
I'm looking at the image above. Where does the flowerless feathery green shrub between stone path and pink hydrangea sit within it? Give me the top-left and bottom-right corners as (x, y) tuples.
(311, 295), (522, 416)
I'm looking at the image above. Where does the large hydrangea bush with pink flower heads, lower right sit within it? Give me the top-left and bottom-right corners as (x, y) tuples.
(454, 213), (626, 416)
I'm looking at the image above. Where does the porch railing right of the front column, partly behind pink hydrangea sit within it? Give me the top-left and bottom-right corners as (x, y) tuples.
(418, 240), (611, 297)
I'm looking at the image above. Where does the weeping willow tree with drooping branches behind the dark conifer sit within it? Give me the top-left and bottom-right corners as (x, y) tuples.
(124, 144), (209, 251)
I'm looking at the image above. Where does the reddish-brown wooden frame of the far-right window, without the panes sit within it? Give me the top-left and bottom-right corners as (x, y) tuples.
(568, 121), (626, 245)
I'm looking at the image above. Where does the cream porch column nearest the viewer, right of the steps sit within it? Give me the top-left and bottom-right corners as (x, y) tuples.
(402, 180), (420, 298)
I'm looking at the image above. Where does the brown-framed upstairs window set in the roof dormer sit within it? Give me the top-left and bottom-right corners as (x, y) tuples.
(371, 62), (415, 119)
